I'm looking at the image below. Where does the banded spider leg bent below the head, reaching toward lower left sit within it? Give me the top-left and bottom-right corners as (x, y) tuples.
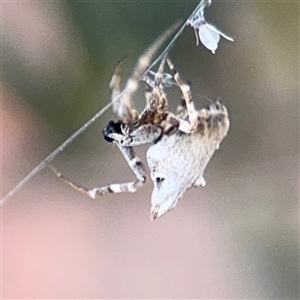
(48, 144), (146, 199)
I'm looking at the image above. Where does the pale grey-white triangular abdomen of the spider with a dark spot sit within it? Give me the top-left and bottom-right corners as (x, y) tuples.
(147, 102), (229, 219)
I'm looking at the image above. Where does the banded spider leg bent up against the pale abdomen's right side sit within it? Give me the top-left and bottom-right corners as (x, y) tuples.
(167, 58), (198, 133)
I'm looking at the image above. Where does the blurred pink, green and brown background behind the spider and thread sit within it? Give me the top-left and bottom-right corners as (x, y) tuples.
(1, 1), (299, 299)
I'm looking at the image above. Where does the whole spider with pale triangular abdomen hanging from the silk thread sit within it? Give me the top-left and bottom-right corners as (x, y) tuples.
(50, 29), (229, 220)
